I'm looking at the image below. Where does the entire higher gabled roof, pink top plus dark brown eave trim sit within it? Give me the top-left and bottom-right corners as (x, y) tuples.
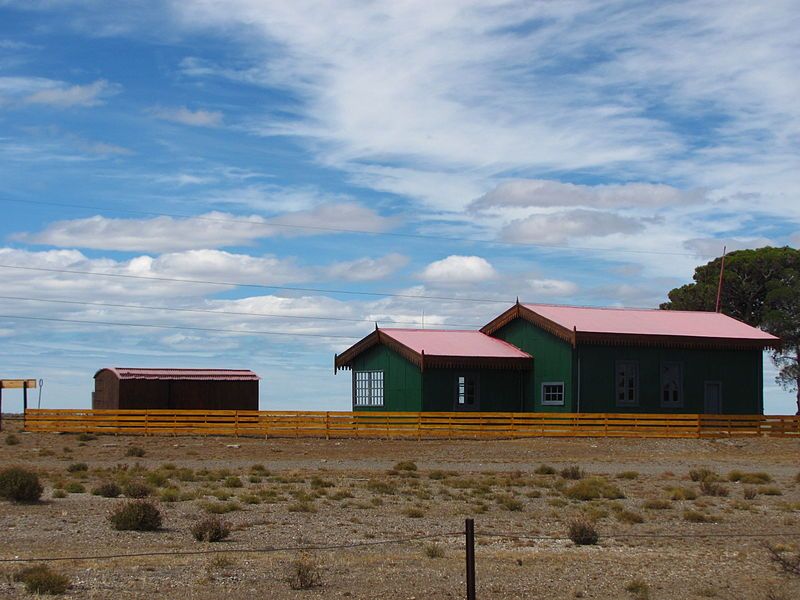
(481, 304), (780, 348)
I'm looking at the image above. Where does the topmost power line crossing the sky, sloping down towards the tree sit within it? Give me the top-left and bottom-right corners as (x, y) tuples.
(2, 198), (695, 257)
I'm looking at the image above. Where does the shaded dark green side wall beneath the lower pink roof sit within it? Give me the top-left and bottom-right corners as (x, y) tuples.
(423, 369), (528, 412)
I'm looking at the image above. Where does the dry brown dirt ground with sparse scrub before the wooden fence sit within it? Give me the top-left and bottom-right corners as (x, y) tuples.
(0, 422), (800, 600)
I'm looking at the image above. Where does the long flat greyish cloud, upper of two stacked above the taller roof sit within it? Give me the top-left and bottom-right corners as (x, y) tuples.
(470, 179), (703, 210)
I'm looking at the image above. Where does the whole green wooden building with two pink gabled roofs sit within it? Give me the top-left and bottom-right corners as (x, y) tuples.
(335, 303), (779, 414)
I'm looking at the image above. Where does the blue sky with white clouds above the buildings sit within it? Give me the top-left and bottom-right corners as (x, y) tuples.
(0, 0), (800, 414)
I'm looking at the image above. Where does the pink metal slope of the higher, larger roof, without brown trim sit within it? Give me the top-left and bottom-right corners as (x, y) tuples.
(523, 304), (778, 341)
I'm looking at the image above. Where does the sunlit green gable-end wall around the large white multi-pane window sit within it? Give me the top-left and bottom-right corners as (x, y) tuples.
(351, 345), (422, 412)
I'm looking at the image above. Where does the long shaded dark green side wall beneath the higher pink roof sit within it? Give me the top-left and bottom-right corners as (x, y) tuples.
(576, 345), (763, 414)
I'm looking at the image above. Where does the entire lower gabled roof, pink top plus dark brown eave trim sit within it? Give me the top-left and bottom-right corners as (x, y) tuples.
(334, 329), (532, 369)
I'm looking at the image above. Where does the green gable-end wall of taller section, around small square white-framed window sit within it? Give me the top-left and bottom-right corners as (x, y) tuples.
(493, 319), (575, 412)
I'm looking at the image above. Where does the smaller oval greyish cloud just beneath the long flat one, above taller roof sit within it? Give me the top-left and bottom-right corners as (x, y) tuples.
(500, 209), (644, 244)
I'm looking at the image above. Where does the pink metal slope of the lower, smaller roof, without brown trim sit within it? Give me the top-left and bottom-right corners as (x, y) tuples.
(379, 328), (531, 358)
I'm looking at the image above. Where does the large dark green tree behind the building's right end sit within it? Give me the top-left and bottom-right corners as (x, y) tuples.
(661, 246), (800, 414)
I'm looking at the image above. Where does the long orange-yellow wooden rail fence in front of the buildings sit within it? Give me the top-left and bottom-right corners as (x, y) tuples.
(24, 409), (800, 439)
